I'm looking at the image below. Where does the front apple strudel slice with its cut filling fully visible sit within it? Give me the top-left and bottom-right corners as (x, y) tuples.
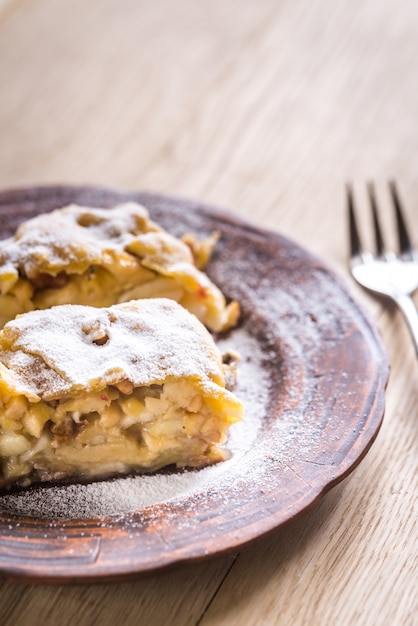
(0, 298), (242, 489)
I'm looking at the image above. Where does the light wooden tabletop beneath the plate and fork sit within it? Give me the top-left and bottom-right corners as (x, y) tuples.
(0, 0), (418, 626)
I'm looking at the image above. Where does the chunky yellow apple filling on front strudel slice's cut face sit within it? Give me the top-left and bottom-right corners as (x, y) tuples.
(0, 380), (239, 486)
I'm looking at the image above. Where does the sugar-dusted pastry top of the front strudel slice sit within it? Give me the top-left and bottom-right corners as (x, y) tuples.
(0, 298), (229, 400)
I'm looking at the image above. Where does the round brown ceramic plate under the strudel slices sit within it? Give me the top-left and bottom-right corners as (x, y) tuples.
(0, 187), (388, 581)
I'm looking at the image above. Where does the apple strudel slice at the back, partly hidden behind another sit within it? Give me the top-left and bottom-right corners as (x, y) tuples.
(0, 202), (239, 332)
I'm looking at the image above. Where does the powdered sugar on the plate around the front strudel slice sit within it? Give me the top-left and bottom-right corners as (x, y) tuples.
(0, 329), (270, 520)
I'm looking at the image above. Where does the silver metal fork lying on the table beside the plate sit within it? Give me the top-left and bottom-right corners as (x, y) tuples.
(347, 182), (418, 356)
